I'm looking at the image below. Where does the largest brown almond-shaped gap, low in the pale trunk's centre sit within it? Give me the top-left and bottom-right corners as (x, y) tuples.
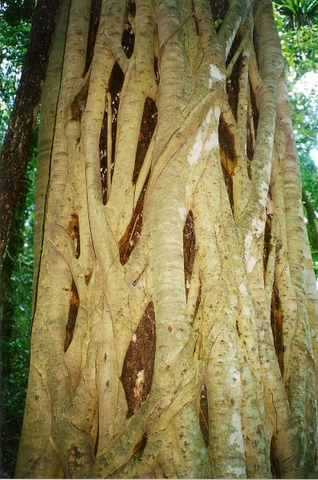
(120, 302), (156, 418)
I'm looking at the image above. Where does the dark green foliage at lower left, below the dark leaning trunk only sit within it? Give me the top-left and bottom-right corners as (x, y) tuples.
(0, 158), (35, 477)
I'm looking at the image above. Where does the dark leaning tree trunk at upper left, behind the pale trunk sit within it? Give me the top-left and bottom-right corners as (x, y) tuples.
(0, 0), (61, 260)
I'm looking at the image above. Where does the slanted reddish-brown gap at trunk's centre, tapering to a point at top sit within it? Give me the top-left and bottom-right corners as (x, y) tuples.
(118, 172), (150, 265)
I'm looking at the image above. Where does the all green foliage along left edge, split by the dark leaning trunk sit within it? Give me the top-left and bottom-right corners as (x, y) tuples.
(0, 0), (35, 477)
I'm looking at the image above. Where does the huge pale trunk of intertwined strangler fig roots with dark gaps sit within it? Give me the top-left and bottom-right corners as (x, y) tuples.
(16, 0), (318, 478)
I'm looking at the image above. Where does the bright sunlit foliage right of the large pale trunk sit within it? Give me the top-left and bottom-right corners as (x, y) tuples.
(273, 0), (318, 278)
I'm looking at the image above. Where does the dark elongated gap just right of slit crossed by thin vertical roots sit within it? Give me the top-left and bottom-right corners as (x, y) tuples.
(133, 97), (157, 183)
